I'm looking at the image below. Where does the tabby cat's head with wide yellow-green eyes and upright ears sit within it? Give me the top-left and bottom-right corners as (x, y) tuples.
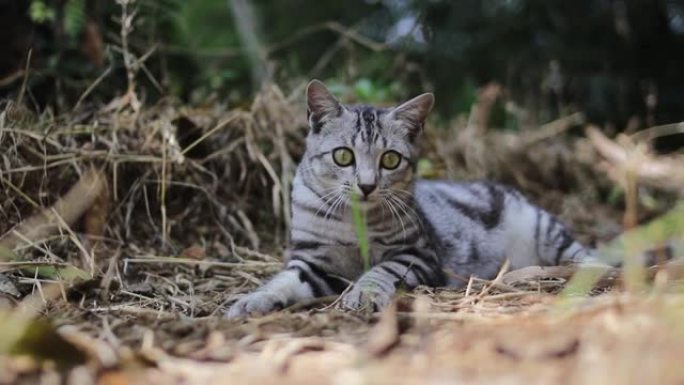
(300, 80), (434, 207)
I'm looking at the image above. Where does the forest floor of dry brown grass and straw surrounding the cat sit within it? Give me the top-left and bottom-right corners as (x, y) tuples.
(0, 88), (684, 385)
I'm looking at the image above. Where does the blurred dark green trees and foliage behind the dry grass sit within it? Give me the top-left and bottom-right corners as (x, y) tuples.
(0, 0), (684, 129)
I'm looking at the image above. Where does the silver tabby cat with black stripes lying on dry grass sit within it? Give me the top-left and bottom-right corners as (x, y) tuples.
(227, 80), (590, 317)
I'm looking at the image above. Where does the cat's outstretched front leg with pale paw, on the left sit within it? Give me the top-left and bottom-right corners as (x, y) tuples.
(226, 251), (347, 318)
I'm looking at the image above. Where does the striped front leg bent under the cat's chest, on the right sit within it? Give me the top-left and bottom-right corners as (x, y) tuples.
(341, 247), (445, 310)
